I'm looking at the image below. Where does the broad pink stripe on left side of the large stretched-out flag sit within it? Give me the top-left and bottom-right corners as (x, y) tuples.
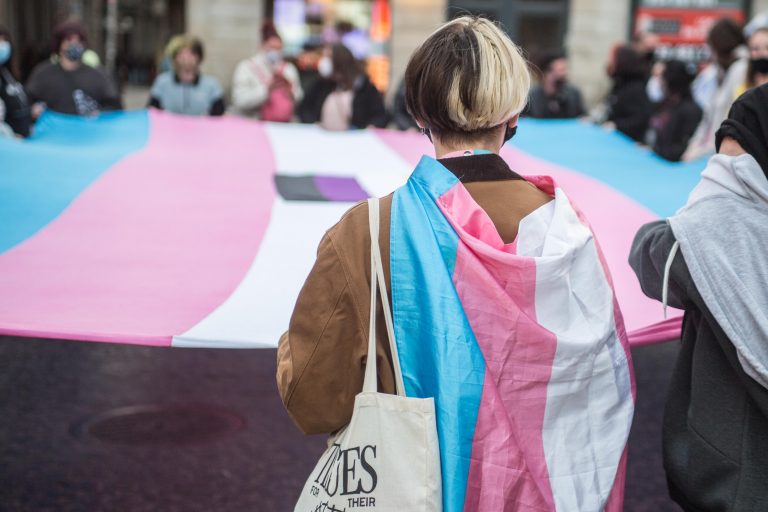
(0, 112), (275, 346)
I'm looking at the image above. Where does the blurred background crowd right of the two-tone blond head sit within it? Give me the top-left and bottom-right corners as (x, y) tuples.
(525, 18), (768, 161)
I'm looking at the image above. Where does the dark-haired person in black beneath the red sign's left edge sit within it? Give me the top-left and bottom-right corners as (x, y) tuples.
(607, 46), (653, 142)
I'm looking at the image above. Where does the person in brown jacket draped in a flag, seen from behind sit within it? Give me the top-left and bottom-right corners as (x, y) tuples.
(277, 17), (635, 511)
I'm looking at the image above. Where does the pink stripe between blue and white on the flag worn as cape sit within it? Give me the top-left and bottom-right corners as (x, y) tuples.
(438, 185), (557, 511)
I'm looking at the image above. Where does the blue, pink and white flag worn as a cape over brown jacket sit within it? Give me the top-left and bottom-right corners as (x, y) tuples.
(391, 157), (634, 512)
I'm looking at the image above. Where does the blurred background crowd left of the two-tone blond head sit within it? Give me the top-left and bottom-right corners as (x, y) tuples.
(0, 21), (391, 137)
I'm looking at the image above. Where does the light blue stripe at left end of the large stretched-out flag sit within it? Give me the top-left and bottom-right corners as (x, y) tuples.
(0, 111), (149, 253)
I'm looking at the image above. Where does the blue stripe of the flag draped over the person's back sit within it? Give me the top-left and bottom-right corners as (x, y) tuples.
(390, 157), (485, 512)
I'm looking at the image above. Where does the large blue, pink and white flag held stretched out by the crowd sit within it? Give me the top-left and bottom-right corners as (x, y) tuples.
(0, 111), (703, 347)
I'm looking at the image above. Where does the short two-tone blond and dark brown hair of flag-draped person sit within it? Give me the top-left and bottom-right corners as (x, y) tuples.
(405, 16), (531, 136)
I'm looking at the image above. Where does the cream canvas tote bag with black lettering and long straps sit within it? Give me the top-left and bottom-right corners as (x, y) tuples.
(294, 199), (443, 512)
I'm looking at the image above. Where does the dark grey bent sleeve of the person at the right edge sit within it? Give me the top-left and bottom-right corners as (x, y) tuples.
(629, 220), (692, 309)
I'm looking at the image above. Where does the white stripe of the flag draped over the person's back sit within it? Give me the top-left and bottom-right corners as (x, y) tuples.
(518, 189), (634, 511)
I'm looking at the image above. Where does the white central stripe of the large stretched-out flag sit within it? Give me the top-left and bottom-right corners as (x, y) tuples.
(172, 124), (411, 348)
